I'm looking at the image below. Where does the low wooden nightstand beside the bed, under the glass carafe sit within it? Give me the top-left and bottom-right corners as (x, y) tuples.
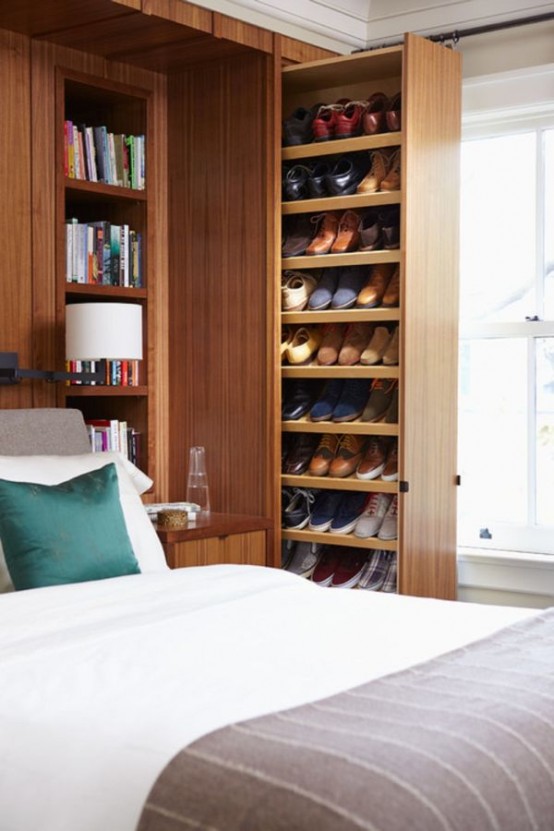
(155, 513), (273, 568)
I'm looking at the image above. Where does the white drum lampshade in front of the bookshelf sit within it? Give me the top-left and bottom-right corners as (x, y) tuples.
(65, 303), (142, 361)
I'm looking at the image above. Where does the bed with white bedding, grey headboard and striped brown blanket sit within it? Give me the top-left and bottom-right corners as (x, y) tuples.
(0, 410), (554, 831)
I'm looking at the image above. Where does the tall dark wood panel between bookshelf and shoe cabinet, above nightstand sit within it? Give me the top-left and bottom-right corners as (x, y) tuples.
(168, 55), (272, 516)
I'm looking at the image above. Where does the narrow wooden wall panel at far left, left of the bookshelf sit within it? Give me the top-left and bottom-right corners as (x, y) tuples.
(0, 30), (33, 409)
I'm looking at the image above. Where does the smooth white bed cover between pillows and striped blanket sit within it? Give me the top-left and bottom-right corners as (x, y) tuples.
(0, 565), (534, 831)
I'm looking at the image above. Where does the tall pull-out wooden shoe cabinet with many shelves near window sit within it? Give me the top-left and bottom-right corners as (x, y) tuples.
(280, 36), (460, 597)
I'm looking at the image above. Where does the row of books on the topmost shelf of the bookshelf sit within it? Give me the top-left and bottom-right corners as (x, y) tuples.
(64, 120), (145, 190)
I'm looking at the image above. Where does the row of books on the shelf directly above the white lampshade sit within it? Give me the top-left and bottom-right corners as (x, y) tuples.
(65, 218), (143, 288)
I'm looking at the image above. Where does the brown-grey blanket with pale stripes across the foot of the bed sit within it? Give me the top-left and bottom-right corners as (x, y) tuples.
(138, 608), (554, 831)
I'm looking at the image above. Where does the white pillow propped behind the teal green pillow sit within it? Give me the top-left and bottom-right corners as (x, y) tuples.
(0, 451), (168, 593)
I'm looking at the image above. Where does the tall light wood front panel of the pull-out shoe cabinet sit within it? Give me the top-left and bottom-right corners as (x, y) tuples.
(399, 35), (461, 598)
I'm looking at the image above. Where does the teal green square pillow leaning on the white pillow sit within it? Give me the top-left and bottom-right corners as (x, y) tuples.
(0, 463), (140, 590)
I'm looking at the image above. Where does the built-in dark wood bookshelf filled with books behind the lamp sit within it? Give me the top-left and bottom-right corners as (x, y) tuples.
(56, 69), (154, 480)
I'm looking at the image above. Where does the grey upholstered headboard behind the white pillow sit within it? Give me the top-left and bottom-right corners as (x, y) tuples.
(0, 407), (91, 456)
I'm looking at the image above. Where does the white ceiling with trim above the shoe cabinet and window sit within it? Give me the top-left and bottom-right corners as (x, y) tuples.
(192, 0), (554, 53)
